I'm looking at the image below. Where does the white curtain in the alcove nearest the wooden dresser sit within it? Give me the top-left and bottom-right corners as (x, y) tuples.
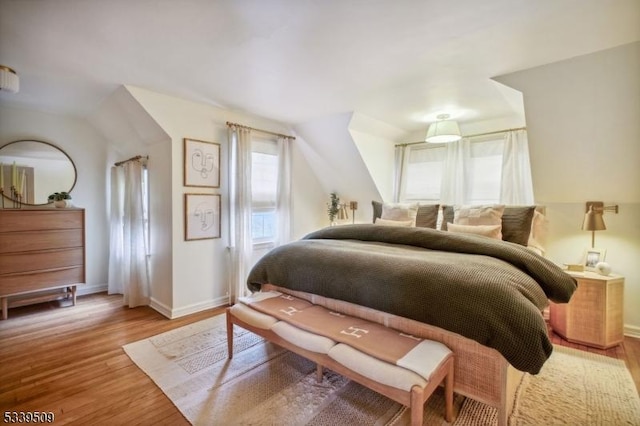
(107, 161), (150, 308)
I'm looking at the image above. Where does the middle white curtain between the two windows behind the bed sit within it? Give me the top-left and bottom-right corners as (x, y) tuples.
(440, 138), (471, 205)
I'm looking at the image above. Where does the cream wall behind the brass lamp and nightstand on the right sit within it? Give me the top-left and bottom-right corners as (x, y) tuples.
(490, 42), (640, 335)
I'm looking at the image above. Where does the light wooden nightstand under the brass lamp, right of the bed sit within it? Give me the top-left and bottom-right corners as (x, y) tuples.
(549, 271), (624, 349)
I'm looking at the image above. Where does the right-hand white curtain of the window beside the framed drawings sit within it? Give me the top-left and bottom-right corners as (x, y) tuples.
(275, 137), (291, 246)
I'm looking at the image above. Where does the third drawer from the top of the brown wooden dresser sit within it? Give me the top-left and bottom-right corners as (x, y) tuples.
(0, 247), (84, 275)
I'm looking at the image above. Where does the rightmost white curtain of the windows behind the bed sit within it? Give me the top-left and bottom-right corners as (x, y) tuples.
(500, 130), (534, 205)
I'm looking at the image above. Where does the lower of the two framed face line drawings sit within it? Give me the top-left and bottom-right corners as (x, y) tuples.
(184, 194), (222, 241)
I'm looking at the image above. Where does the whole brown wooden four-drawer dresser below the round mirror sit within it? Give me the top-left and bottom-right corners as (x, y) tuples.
(0, 208), (85, 319)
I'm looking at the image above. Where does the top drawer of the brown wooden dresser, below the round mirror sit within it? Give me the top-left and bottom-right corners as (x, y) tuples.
(0, 208), (84, 233)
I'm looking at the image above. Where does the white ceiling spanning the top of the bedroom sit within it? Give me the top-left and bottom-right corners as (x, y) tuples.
(0, 0), (640, 131)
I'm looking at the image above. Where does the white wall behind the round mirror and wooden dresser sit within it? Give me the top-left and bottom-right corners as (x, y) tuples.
(0, 105), (109, 294)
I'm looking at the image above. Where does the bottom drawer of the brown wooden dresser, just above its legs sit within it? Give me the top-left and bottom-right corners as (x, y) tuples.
(0, 266), (84, 296)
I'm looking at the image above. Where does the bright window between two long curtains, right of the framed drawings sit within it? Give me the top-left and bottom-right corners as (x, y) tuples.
(251, 139), (278, 245)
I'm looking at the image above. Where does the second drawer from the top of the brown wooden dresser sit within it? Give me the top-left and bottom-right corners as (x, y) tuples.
(0, 229), (84, 253)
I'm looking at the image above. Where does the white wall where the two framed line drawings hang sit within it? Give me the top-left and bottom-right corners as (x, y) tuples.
(127, 87), (319, 317)
